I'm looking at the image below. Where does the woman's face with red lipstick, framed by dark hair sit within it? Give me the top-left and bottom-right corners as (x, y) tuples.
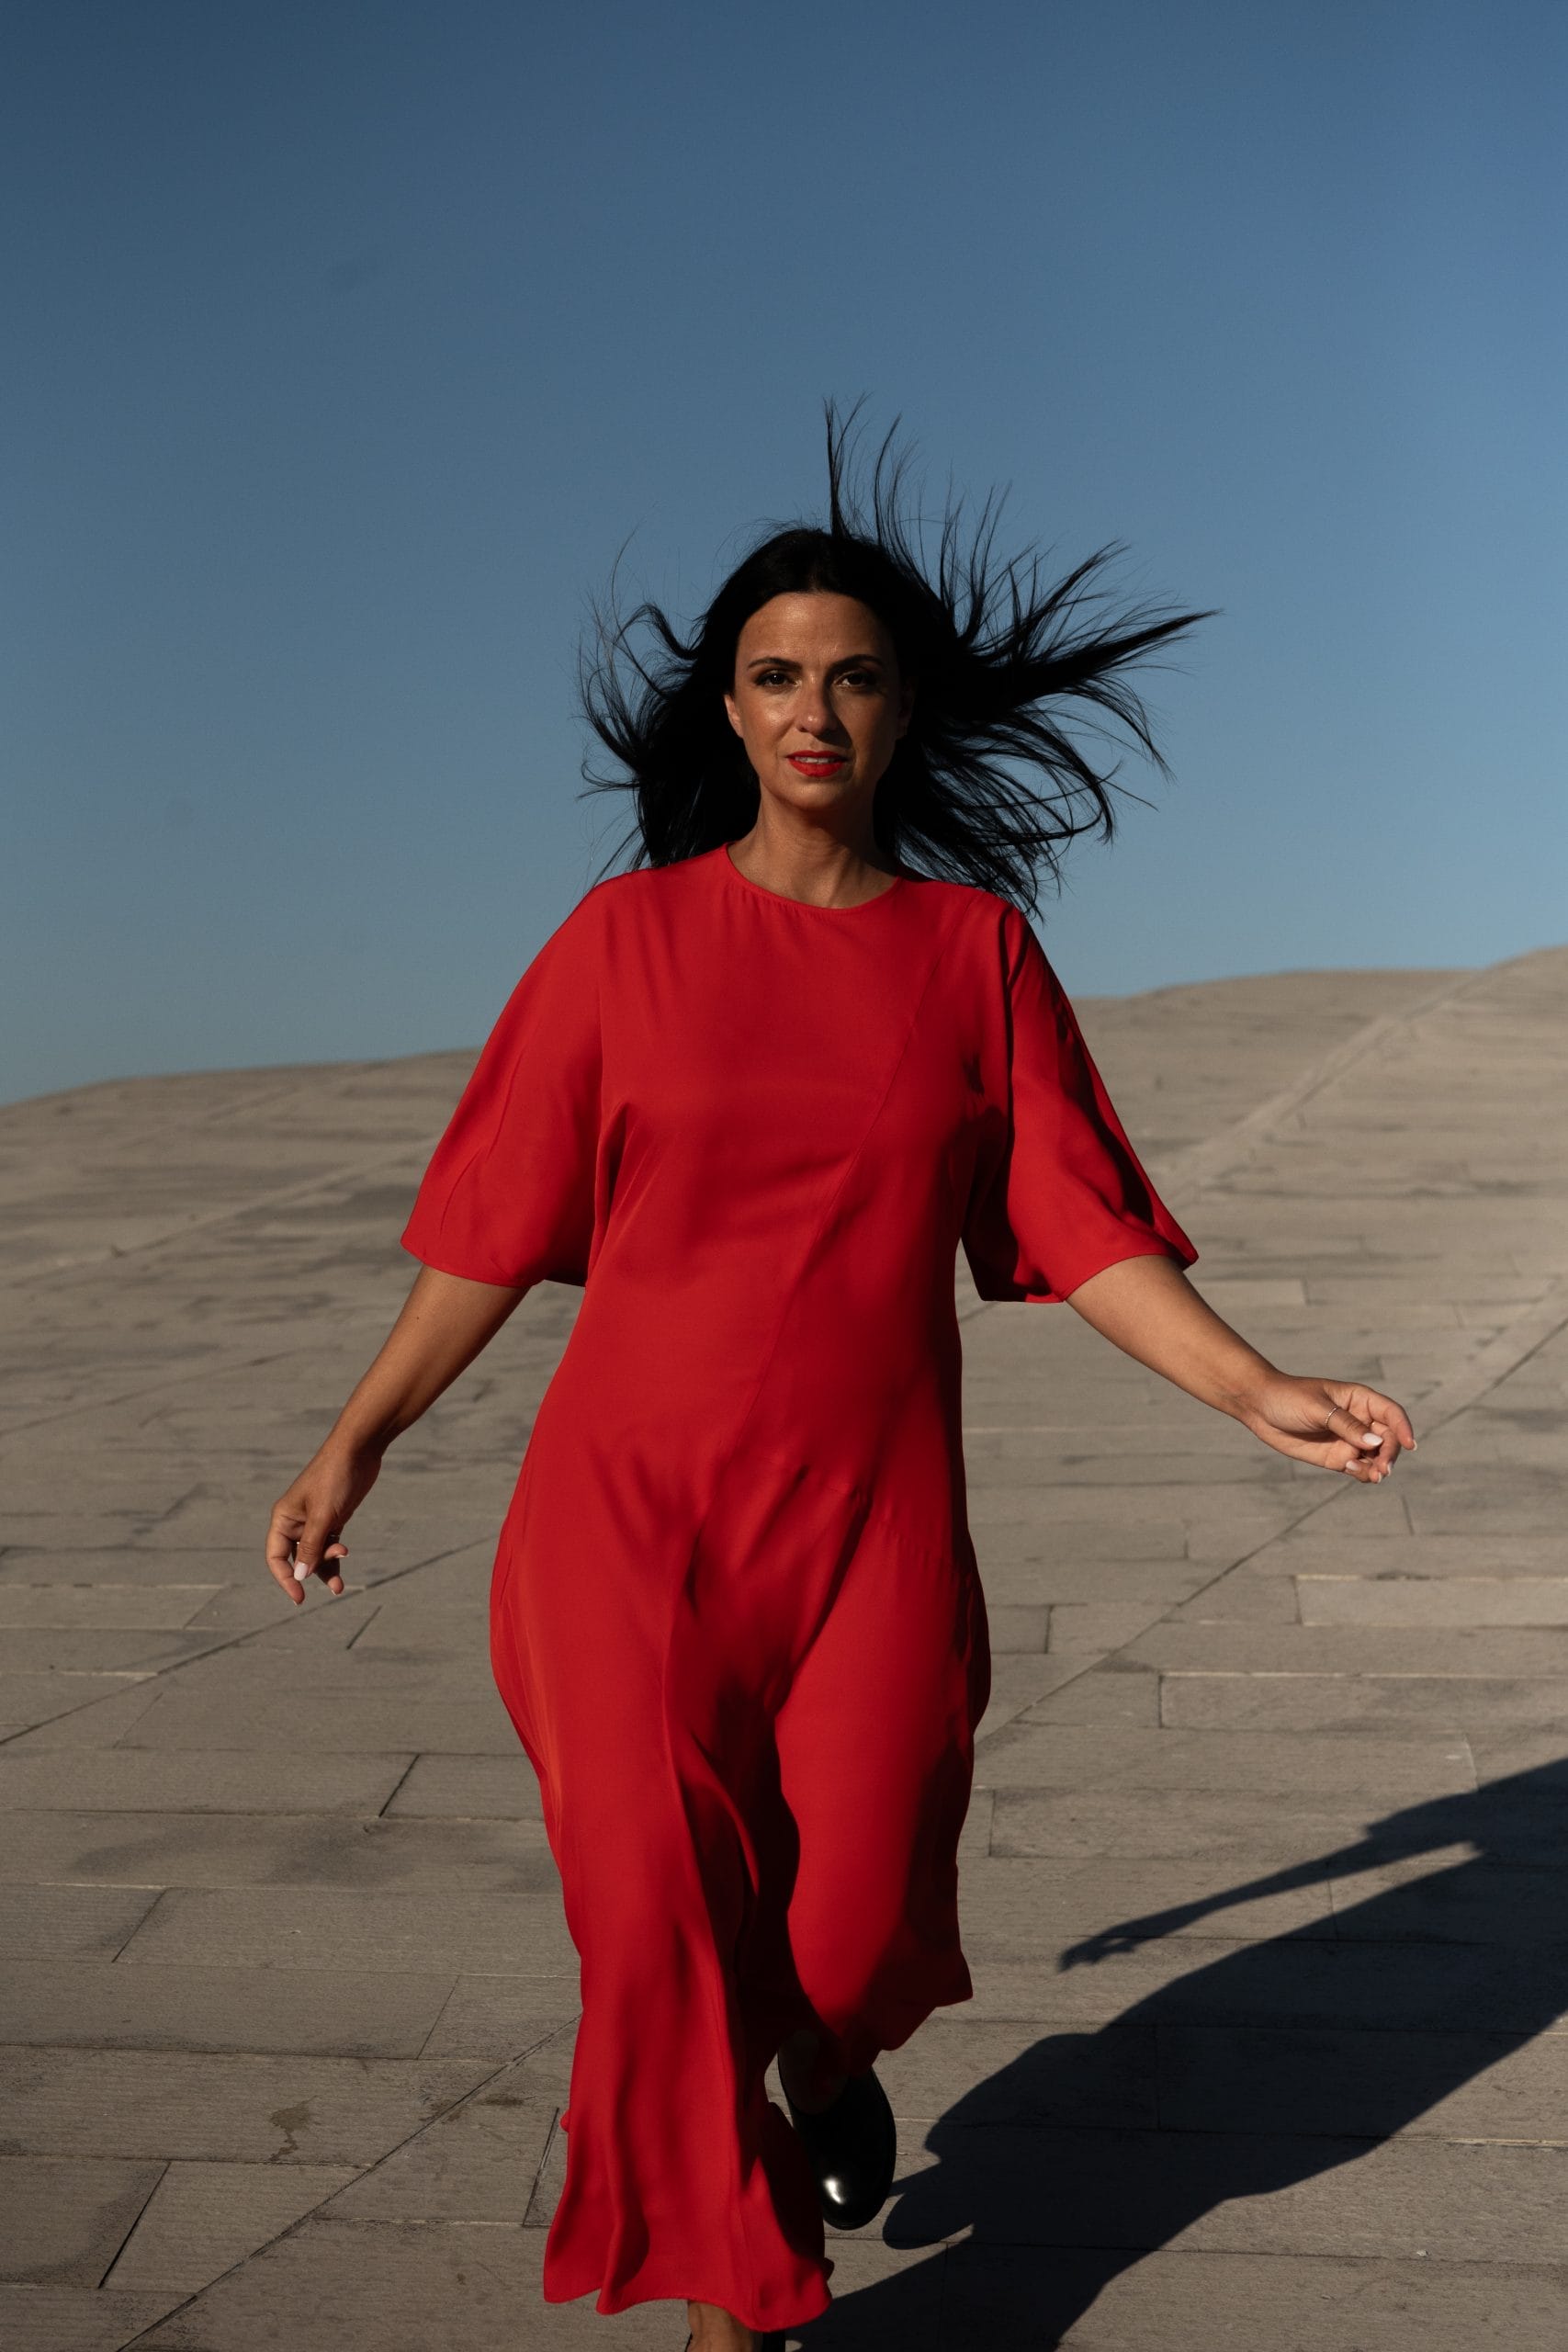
(724, 588), (915, 832)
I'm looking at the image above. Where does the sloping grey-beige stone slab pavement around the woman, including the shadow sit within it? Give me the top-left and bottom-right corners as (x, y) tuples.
(0, 950), (1568, 2352)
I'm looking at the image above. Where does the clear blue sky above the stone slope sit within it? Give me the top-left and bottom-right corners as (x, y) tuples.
(0, 0), (1568, 1099)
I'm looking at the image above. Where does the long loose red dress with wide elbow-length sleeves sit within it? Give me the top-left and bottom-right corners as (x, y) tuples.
(402, 847), (1197, 2328)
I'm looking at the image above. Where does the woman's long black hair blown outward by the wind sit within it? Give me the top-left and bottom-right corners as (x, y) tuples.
(581, 402), (1211, 912)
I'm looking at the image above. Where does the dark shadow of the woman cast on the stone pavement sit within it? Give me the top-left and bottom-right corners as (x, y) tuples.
(802, 1757), (1568, 2352)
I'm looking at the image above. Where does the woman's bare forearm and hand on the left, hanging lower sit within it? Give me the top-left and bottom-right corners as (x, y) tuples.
(265, 1265), (526, 1604)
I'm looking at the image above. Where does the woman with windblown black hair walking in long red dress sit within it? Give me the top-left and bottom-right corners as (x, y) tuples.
(268, 416), (1416, 2352)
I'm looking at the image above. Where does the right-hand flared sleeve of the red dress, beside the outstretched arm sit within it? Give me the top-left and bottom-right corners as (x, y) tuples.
(964, 908), (1197, 1301)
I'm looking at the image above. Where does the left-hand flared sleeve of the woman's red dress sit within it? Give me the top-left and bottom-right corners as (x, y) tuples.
(402, 891), (602, 1289)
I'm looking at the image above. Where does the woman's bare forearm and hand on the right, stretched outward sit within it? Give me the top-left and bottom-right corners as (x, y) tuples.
(1067, 1256), (1416, 1487)
